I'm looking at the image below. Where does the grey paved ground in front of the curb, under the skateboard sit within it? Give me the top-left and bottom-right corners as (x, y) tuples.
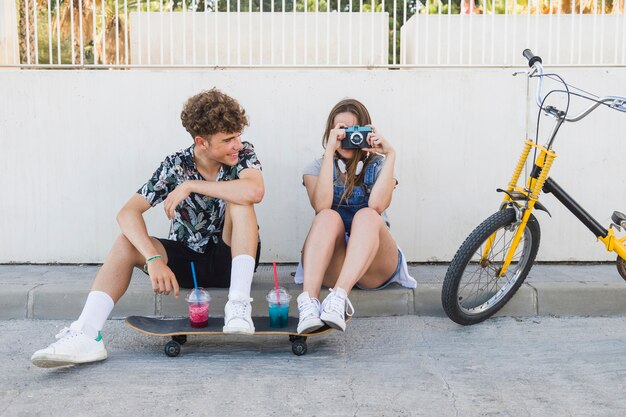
(0, 316), (626, 417)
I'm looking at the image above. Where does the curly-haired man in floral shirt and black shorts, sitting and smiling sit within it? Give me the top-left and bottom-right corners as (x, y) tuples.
(31, 89), (265, 368)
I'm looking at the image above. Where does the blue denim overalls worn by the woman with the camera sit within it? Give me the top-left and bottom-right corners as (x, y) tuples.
(332, 158), (384, 234)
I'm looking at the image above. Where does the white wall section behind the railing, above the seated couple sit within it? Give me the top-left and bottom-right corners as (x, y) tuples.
(130, 12), (389, 65)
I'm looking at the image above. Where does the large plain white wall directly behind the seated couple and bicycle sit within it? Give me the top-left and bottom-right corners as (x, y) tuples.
(0, 68), (626, 262)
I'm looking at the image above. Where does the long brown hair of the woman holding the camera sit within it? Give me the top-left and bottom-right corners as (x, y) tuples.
(322, 98), (372, 204)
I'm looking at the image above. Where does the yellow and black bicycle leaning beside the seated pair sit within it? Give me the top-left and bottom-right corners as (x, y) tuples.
(441, 49), (626, 325)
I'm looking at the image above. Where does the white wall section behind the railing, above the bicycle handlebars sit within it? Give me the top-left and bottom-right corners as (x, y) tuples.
(400, 14), (626, 65)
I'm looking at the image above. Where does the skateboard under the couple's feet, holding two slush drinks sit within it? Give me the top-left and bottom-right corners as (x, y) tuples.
(126, 316), (349, 357)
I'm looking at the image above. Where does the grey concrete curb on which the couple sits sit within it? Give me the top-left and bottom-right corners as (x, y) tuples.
(0, 264), (626, 320)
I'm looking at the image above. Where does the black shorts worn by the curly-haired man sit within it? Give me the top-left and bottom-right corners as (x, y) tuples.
(159, 238), (261, 288)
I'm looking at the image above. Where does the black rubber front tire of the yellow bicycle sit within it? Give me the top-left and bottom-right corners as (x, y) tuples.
(441, 208), (541, 325)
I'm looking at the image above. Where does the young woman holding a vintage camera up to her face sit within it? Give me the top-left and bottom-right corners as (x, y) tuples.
(296, 99), (416, 333)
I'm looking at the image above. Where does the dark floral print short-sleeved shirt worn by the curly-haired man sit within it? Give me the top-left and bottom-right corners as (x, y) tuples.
(137, 142), (261, 253)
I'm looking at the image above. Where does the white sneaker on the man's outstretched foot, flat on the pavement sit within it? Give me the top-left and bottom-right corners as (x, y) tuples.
(30, 321), (107, 368)
